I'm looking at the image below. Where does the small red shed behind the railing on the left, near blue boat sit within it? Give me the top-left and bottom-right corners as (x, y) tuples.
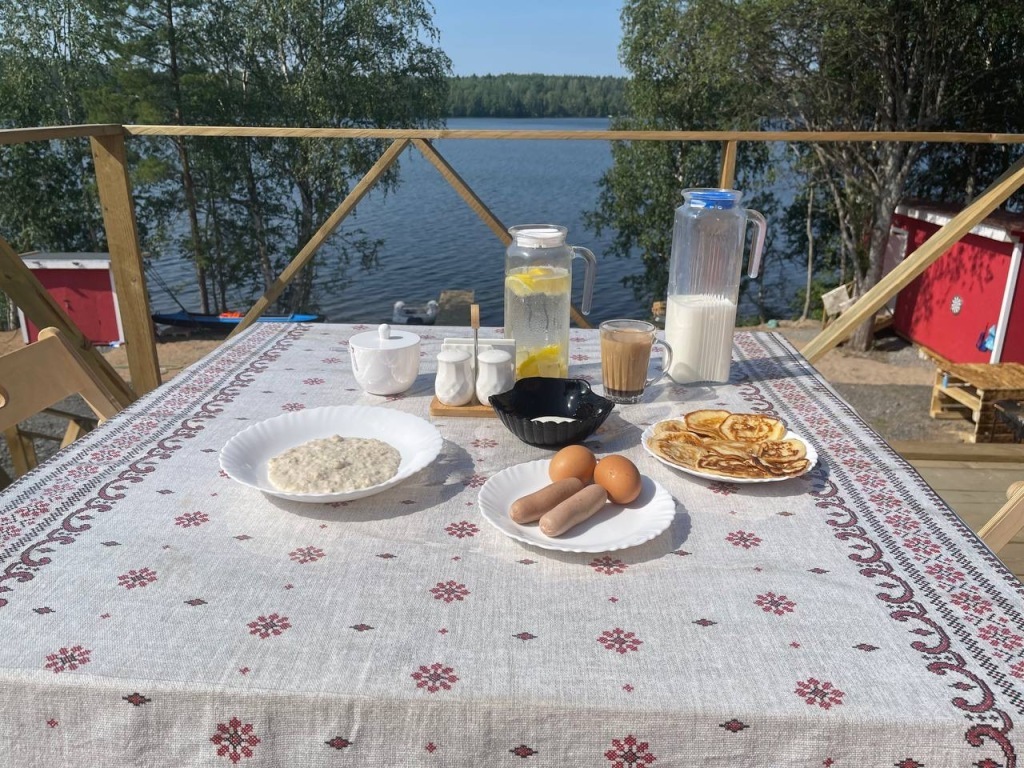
(17, 251), (124, 344)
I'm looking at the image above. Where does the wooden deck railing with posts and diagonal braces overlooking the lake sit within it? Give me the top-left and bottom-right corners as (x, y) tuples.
(0, 125), (1024, 398)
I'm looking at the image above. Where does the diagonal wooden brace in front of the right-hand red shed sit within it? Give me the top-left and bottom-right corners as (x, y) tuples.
(801, 158), (1024, 362)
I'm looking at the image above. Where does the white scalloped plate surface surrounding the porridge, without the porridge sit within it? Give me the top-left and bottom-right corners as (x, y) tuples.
(220, 406), (443, 504)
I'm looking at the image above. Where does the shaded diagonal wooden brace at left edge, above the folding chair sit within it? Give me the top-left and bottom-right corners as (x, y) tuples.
(0, 238), (135, 408)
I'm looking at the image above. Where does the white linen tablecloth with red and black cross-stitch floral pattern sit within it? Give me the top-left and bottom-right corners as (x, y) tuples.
(0, 324), (1024, 768)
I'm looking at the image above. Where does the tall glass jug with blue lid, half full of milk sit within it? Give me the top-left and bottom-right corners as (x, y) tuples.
(665, 189), (767, 384)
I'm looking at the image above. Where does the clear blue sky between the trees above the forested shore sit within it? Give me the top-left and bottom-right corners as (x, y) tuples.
(433, 0), (625, 76)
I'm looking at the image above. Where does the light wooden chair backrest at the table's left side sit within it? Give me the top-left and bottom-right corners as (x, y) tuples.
(0, 328), (121, 430)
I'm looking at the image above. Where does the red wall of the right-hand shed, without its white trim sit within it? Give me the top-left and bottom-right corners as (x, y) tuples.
(893, 214), (1011, 362)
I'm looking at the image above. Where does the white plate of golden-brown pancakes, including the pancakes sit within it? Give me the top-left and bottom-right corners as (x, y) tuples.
(641, 410), (818, 482)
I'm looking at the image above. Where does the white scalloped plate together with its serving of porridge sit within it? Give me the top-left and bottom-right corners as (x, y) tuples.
(220, 406), (442, 504)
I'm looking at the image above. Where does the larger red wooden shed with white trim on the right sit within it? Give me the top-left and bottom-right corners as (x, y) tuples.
(889, 203), (1024, 364)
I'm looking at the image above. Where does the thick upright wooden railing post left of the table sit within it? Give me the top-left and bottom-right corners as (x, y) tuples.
(89, 133), (160, 394)
